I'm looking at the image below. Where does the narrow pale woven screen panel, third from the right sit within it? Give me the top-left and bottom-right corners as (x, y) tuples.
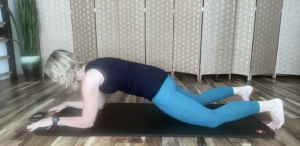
(232, 0), (256, 76)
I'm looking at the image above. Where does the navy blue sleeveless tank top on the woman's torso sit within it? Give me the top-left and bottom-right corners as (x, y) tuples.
(85, 57), (168, 101)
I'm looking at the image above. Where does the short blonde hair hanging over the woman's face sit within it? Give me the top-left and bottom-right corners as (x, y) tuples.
(45, 49), (87, 90)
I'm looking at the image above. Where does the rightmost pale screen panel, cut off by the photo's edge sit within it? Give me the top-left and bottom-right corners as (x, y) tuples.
(276, 0), (300, 75)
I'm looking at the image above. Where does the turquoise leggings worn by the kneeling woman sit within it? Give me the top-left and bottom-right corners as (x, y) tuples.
(152, 76), (259, 128)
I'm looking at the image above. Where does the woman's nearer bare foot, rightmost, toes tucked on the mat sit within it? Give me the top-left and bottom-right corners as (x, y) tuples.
(268, 99), (285, 129)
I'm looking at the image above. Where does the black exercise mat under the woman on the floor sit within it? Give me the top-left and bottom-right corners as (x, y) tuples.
(34, 103), (275, 138)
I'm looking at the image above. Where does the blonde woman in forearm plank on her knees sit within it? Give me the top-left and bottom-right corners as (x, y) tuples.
(27, 50), (284, 131)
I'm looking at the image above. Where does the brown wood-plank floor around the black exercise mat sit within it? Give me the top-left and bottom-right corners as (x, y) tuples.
(0, 74), (300, 146)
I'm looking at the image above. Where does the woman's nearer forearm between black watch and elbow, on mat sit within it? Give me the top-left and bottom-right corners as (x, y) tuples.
(57, 117), (93, 128)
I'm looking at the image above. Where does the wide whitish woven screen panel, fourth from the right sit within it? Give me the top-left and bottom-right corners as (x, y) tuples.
(200, 0), (236, 75)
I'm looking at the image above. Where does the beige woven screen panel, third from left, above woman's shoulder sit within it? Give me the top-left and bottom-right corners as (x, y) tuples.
(95, 0), (120, 58)
